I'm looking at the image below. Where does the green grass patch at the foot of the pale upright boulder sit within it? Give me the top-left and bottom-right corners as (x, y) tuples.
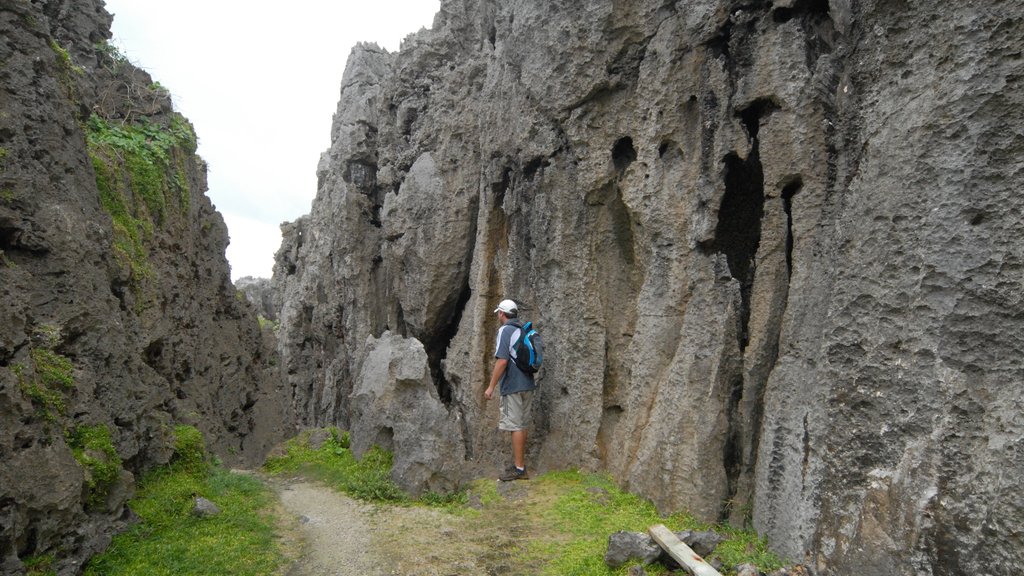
(263, 428), (409, 503)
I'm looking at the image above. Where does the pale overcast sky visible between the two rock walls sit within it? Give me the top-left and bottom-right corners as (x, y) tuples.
(106, 0), (440, 280)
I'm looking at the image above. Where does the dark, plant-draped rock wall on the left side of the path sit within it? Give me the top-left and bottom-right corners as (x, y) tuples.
(0, 0), (292, 574)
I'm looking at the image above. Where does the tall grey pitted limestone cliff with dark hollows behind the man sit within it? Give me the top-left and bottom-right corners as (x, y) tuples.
(274, 0), (1024, 575)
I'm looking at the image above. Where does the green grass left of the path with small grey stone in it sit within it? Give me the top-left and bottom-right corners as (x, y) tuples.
(85, 467), (288, 576)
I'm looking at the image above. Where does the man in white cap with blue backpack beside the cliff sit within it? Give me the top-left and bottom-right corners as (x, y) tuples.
(483, 300), (537, 482)
